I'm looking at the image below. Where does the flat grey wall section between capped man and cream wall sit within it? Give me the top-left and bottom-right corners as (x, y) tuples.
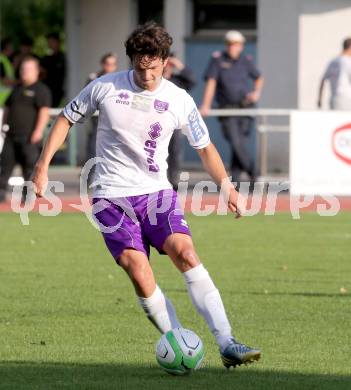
(257, 0), (300, 108)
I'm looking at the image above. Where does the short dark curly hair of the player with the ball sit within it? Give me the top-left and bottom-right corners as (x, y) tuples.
(124, 21), (173, 61)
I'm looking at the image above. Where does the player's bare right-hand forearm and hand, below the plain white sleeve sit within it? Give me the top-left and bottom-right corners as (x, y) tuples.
(197, 142), (245, 218)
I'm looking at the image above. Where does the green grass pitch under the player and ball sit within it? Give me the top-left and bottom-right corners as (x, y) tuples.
(0, 213), (351, 390)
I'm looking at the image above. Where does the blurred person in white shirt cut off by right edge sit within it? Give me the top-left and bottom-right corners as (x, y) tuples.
(317, 38), (351, 110)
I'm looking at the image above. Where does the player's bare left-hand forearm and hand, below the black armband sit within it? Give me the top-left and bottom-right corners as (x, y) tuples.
(32, 114), (72, 196)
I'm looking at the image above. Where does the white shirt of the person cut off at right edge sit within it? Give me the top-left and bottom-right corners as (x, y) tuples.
(323, 55), (351, 110)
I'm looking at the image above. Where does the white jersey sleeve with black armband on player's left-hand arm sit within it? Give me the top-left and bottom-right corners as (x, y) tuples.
(63, 80), (99, 123)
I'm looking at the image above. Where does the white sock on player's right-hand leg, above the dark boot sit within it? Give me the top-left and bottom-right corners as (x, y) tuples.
(183, 264), (232, 351)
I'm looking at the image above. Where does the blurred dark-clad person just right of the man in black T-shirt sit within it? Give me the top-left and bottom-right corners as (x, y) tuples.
(41, 33), (66, 107)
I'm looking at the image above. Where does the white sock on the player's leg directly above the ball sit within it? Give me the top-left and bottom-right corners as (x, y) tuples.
(138, 286), (181, 333)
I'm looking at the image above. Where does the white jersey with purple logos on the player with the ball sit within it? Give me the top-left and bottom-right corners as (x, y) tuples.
(63, 71), (210, 198)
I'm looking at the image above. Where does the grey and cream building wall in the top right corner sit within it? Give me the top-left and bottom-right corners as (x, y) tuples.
(257, 0), (351, 172)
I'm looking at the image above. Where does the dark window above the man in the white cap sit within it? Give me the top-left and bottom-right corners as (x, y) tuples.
(193, 0), (257, 33)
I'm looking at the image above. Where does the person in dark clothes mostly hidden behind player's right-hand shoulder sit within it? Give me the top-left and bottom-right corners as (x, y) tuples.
(163, 53), (196, 190)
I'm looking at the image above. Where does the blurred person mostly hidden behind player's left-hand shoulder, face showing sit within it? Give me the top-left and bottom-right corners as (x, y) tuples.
(87, 52), (118, 174)
